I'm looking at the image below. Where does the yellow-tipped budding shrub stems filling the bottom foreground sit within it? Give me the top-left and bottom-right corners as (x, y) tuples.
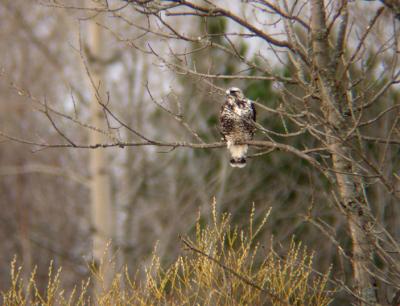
(2, 205), (332, 305)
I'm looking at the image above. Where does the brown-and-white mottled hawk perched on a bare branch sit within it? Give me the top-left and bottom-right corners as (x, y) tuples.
(219, 87), (256, 168)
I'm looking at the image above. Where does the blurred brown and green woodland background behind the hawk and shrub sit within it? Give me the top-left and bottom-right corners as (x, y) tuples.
(0, 0), (400, 305)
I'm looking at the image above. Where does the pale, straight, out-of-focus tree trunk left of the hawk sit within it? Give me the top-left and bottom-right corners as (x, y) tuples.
(88, 8), (114, 293)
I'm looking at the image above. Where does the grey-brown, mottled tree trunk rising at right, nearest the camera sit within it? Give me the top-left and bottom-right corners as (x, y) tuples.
(311, 0), (377, 305)
